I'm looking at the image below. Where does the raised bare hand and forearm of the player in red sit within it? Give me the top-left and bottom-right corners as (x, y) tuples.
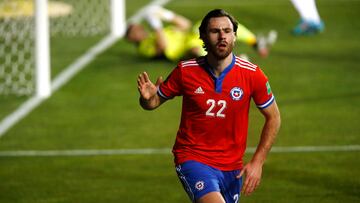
(137, 72), (166, 110)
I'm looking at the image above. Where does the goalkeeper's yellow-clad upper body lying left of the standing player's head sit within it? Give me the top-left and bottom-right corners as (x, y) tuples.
(126, 6), (205, 61)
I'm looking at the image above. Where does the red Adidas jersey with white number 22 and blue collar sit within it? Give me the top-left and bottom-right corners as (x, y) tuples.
(158, 55), (274, 171)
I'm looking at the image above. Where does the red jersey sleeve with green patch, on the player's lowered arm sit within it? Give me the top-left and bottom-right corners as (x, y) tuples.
(252, 68), (275, 109)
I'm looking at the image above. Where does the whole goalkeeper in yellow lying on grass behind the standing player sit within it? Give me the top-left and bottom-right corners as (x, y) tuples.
(125, 5), (276, 61)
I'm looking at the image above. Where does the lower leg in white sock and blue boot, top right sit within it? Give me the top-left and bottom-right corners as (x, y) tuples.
(291, 0), (325, 36)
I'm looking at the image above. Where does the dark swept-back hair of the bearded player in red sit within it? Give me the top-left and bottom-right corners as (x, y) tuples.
(199, 9), (238, 38)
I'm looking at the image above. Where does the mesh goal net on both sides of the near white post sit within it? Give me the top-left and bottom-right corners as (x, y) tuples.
(0, 0), (123, 96)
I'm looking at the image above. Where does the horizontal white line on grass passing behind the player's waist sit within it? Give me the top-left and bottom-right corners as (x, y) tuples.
(0, 145), (360, 157)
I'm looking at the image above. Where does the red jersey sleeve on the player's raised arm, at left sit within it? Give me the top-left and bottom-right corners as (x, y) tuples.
(158, 65), (182, 99)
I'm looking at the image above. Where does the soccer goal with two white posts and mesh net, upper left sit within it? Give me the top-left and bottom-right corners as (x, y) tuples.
(0, 0), (126, 98)
